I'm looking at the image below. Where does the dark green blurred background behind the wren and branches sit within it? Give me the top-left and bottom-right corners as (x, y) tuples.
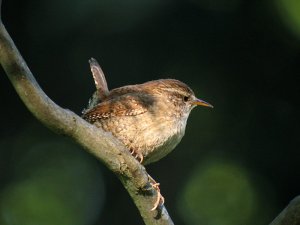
(0, 0), (300, 225)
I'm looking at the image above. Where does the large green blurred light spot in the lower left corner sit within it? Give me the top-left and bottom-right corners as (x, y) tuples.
(0, 128), (105, 225)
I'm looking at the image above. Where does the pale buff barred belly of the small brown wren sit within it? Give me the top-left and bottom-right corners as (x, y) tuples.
(95, 116), (186, 164)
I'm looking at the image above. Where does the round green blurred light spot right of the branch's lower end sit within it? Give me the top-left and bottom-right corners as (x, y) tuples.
(178, 160), (272, 225)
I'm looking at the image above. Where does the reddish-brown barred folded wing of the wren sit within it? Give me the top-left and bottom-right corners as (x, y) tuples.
(82, 94), (153, 123)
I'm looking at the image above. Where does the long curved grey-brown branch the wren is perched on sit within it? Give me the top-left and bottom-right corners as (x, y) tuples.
(0, 0), (173, 225)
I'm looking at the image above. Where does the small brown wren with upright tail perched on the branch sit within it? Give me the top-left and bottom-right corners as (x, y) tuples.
(82, 59), (213, 165)
